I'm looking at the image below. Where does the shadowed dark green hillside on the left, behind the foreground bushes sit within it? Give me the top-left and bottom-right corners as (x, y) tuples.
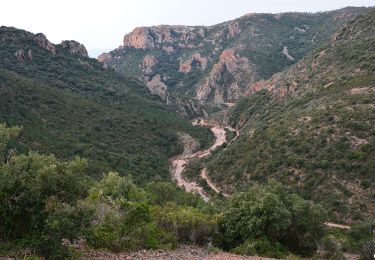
(0, 27), (212, 182)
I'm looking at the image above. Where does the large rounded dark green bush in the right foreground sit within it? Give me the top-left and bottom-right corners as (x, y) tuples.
(219, 181), (326, 255)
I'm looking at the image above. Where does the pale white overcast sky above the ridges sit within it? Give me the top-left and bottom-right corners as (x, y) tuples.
(0, 0), (375, 56)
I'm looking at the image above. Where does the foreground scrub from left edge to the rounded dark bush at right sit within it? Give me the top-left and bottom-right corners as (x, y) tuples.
(0, 125), (216, 258)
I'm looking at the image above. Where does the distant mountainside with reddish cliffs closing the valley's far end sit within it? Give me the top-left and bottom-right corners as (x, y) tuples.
(99, 8), (366, 108)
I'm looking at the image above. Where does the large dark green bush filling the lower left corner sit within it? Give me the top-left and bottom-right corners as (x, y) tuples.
(0, 152), (88, 239)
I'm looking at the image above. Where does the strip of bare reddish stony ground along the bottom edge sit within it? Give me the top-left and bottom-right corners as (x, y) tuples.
(82, 246), (271, 260)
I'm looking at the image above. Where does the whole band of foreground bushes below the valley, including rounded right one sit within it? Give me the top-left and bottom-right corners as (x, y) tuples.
(0, 125), (356, 259)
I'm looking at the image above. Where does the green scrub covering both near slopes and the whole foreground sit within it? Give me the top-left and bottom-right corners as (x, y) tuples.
(0, 9), (375, 259)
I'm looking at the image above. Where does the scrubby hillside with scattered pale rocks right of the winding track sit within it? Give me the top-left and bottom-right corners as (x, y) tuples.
(198, 11), (375, 223)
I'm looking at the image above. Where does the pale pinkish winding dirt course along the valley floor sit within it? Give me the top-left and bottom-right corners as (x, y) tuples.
(170, 119), (239, 202)
